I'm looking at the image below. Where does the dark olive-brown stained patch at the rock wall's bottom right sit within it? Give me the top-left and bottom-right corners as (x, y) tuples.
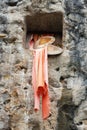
(56, 88), (78, 130)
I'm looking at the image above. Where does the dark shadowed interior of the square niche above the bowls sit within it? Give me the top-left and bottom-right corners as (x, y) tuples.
(25, 12), (63, 47)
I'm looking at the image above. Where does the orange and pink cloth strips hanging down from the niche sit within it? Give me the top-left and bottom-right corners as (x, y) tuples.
(32, 47), (50, 119)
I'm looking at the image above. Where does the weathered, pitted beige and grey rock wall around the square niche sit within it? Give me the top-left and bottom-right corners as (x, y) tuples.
(0, 0), (87, 130)
